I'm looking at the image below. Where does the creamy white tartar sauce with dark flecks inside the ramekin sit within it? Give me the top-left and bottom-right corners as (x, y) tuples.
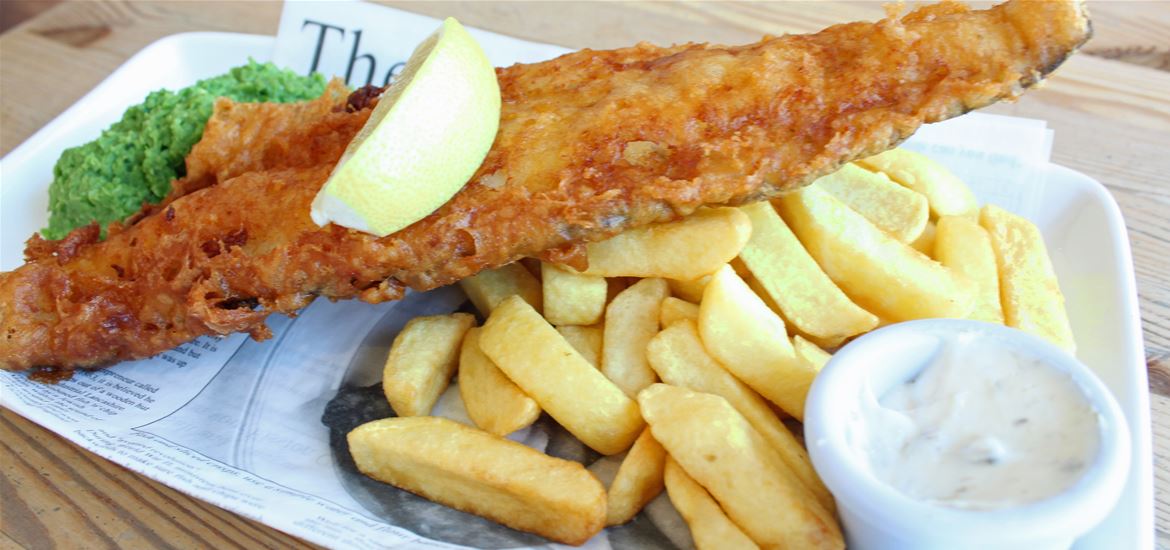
(854, 332), (1100, 509)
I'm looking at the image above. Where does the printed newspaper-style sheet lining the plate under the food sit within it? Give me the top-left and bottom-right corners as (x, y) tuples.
(0, 2), (1052, 549)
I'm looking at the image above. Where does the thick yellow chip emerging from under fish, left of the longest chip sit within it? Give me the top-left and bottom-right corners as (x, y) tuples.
(739, 202), (878, 338)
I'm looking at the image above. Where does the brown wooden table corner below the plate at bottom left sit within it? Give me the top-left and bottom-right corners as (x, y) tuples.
(0, 410), (312, 549)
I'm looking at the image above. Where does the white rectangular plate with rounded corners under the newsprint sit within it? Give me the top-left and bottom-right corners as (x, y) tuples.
(0, 33), (1154, 549)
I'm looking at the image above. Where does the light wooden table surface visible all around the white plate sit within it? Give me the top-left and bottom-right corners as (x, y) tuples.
(0, 1), (1170, 548)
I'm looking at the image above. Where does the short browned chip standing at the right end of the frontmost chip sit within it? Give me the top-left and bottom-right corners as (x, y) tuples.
(605, 428), (666, 525)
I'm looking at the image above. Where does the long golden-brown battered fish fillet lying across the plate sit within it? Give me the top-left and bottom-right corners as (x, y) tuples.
(0, 0), (1089, 370)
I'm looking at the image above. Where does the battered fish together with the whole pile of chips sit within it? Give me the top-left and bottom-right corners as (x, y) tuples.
(0, 0), (1090, 548)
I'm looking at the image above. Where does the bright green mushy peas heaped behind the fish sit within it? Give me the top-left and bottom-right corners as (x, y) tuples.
(41, 61), (325, 239)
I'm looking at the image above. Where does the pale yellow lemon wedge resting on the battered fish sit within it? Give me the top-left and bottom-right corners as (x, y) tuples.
(310, 18), (500, 236)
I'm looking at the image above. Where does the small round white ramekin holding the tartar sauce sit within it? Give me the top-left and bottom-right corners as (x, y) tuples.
(804, 319), (1130, 550)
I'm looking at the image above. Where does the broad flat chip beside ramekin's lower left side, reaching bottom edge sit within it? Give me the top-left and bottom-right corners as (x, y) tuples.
(638, 383), (845, 548)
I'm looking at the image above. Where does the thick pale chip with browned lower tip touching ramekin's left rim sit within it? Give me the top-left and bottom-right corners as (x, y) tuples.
(698, 266), (817, 420)
